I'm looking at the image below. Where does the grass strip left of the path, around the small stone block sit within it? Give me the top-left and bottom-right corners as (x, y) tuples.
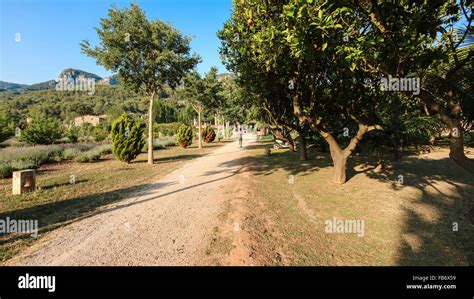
(0, 142), (221, 261)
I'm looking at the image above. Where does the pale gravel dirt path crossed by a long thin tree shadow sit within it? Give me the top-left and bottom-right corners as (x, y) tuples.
(8, 142), (252, 265)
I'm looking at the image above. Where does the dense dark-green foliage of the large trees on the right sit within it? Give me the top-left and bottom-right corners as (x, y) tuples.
(218, 0), (474, 166)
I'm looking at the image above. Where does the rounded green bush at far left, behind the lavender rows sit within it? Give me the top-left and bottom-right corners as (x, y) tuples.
(20, 116), (63, 145)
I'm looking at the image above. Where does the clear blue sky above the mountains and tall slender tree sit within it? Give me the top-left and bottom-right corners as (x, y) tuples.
(0, 0), (232, 84)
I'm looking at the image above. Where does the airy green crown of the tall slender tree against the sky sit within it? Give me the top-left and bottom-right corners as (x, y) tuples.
(81, 3), (200, 95)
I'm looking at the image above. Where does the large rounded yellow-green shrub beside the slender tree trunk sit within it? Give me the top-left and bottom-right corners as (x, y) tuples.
(111, 113), (145, 163)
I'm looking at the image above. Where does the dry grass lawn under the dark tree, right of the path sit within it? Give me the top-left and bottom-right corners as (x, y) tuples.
(233, 146), (474, 265)
